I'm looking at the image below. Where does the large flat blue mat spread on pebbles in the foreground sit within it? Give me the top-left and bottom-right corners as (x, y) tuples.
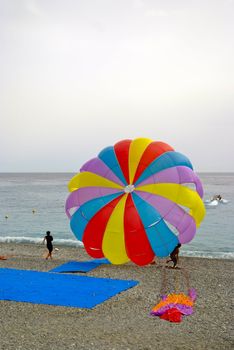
(0, 268), (139, 309)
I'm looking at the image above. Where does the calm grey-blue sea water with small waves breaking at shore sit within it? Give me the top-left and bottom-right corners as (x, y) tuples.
(0, 173), (234, 259)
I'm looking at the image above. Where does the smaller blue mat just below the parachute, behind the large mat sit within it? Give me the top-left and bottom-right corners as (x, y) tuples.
(49, 259), (110, 273)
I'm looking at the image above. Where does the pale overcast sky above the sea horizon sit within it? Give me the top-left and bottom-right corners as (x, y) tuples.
(0, 0), (234, 172)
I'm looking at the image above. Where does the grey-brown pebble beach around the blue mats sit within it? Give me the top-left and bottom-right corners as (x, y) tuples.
(0, 243), (234, 350)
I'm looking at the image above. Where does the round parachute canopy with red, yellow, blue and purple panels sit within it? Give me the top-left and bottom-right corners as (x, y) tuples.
(66, 138), (205, 265)
